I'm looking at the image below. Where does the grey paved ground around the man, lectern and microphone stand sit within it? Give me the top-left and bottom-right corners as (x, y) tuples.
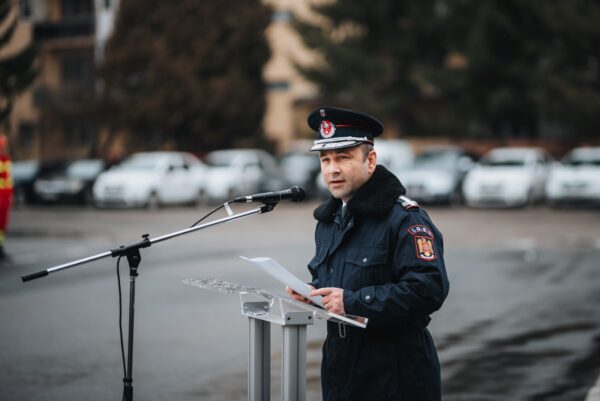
(0, 204), (600, 401)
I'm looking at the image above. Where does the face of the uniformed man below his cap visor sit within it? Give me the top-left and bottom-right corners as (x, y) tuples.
(320, 145), (377, 202)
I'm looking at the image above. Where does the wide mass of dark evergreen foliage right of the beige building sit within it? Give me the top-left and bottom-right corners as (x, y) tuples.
(296, 0), (600, 137)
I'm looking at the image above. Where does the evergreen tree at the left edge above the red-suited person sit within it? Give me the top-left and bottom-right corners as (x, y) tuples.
(0, 0), (36, 126)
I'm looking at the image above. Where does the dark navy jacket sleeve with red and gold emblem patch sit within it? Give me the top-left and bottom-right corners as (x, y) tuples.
(344, 211), (449, 326)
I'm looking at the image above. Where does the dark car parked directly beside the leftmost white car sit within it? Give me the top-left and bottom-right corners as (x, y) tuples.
(33, 159), (106, 204)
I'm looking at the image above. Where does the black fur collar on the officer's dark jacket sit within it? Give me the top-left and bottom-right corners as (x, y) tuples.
(313, 165), (406, 223)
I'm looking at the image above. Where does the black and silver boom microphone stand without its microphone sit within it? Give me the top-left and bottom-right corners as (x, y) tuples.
(21, 200), (279, 401)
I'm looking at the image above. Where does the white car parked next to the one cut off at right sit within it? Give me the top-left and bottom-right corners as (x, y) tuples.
(463, 147), (551, 207)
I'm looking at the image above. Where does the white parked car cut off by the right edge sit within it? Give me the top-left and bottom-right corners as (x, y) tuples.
(546, 147), (600, 206)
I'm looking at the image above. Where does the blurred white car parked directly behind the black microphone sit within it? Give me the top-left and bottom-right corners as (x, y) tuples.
(205, 149), (287, 201)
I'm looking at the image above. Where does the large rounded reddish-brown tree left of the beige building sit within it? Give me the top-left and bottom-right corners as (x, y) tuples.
(101, 0), (270, 151)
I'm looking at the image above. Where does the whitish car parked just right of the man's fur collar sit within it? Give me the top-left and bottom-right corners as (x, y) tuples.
(402, 146), (475, 204)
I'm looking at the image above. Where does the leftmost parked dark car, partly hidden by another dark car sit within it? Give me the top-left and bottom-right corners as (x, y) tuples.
(11, 160), (65, 207)
